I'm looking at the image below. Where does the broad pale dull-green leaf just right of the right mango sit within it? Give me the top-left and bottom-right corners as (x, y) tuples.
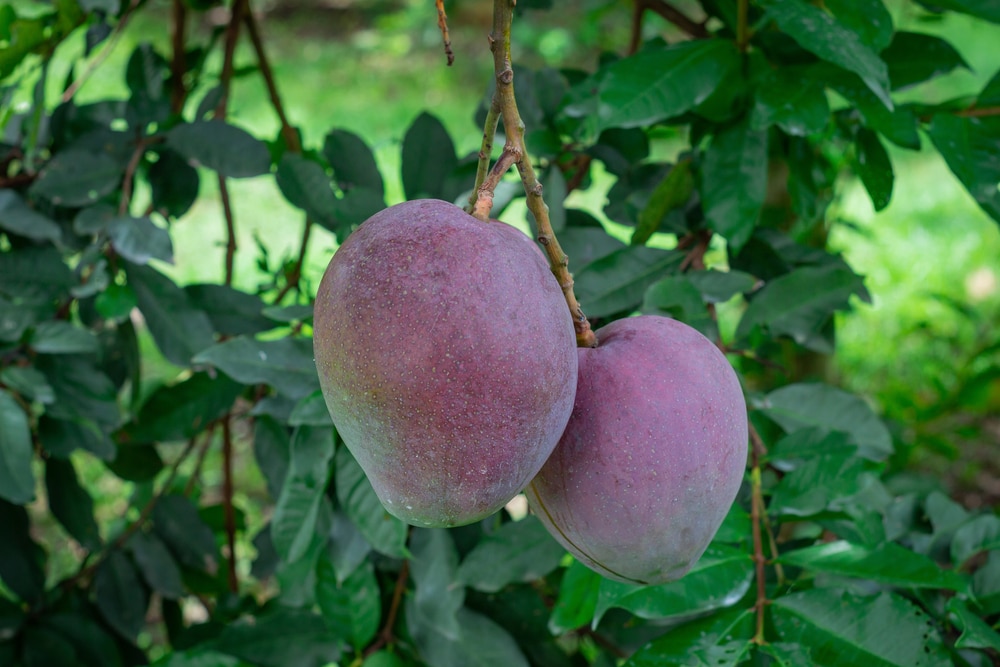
(764, 383), (892, 461)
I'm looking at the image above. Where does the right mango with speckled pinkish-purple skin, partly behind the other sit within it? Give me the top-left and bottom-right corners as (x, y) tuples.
(526, 315), (747, 584)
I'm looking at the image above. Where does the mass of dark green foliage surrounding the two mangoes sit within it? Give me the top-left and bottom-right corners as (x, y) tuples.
(0, 0), (1000, 667)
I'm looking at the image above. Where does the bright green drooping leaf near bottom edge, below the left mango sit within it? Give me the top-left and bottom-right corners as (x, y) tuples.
(316, 558), (382, 652)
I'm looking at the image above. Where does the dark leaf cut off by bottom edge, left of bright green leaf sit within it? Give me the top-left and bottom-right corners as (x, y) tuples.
(206, 606), (341, 667)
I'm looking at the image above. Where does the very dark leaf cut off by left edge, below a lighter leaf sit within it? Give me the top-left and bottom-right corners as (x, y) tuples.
(0, 499), (45, 604)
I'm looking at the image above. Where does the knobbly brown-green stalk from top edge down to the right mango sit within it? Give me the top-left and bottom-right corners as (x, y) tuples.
(484, 0), (597, 347)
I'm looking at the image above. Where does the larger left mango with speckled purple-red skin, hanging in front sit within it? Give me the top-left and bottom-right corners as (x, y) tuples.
(313, 200), (578, 526)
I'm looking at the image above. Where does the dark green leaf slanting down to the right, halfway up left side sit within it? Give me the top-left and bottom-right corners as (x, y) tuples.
(125, 264), (213, 367)
